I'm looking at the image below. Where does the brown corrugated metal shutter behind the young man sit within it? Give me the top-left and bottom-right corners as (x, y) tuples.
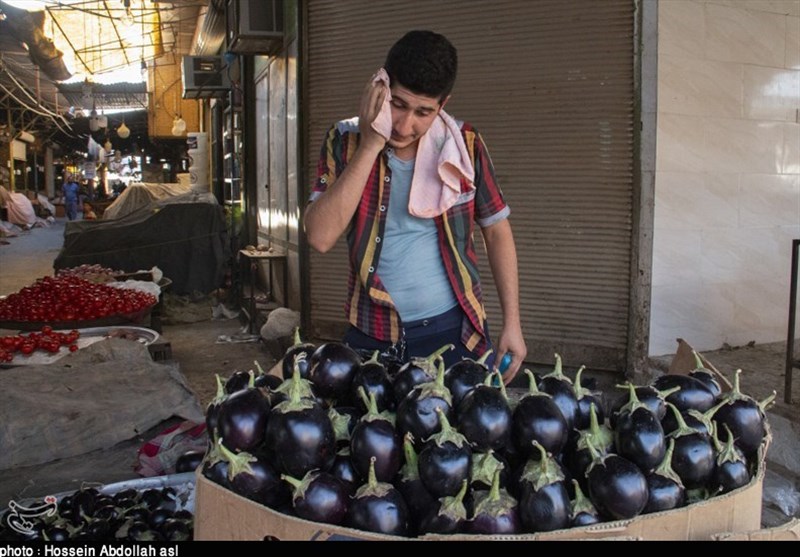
(307, 0), (634, 370)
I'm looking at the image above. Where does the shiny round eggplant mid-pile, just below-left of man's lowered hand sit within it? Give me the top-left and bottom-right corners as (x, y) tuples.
(454, 372), (512, 451)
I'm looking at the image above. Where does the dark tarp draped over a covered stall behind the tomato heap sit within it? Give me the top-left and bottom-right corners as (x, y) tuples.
(53, 193), (230, 295)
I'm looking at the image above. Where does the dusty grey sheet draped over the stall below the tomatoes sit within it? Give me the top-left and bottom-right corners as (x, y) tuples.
(0, 338), (203, 470)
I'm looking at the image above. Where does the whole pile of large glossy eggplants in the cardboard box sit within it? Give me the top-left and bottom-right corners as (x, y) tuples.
(201, 331), (774, 537)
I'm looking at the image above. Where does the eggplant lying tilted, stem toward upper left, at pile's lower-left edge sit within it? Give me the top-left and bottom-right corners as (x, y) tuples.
(217, 438), (289, 508)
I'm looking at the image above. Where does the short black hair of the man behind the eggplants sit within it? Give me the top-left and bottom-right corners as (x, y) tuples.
(383, 31), (458, 103)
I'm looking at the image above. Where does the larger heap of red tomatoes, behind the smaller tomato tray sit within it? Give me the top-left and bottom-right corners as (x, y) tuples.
(0, 275), (158, 323)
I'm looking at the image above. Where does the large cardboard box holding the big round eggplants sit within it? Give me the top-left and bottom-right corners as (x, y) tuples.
(195, 339), (769, 541)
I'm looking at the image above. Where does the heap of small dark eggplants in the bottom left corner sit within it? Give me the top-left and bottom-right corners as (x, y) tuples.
(0, 487), (194, 542)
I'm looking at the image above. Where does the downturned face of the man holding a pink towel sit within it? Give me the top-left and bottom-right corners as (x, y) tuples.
(389, 84), (449, 156)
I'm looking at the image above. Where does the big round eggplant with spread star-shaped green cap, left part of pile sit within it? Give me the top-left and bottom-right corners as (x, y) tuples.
(265, 378), (336, 478)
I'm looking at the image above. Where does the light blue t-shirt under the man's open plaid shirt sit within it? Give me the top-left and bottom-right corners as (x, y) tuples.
(377, 151), (458, 322)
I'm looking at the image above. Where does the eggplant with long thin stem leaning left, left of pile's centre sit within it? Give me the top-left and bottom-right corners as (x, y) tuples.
(350, 387), (403, 483)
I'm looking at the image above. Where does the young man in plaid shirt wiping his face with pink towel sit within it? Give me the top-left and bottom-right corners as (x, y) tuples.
(304, 31), (527, 383)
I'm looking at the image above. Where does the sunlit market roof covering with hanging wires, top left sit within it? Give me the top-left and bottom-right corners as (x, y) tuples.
(0, 0), (217, 152)
